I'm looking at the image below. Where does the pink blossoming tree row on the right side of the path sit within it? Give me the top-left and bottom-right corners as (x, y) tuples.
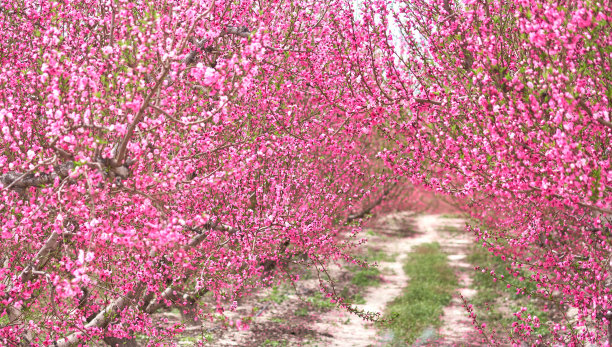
(364, 0), (612, 345)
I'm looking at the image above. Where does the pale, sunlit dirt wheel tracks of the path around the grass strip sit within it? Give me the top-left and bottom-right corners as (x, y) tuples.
(315, 212), (474, 346)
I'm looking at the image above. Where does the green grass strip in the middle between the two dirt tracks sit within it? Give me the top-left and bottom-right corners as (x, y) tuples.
(386, 243), (457, 344)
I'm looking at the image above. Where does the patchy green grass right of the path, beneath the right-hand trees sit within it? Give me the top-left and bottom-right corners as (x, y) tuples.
(468, 246), (550, 336)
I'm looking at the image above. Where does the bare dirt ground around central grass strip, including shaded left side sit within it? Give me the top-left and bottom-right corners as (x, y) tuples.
(148, 212), (479, 346)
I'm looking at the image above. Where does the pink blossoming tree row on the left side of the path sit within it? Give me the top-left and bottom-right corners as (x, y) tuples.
(0, 0), (412, 346)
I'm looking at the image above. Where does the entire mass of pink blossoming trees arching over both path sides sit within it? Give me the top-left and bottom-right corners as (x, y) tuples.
(0, 0), (612, 346)
